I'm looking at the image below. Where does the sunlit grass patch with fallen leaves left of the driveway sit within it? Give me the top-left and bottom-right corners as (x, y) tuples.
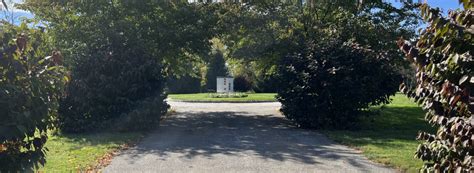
(38, 133), (142, 172)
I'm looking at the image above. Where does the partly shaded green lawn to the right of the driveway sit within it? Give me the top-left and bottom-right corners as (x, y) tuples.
(323, 94), (434, 172)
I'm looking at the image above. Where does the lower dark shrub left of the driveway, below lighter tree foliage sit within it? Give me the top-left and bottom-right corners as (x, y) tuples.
(58, 50), (167, 132)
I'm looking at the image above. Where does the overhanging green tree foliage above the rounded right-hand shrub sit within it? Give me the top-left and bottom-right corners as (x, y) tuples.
(220, 0), (419, 68)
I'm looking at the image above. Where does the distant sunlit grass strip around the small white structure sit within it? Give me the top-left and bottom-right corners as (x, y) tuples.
(168, 93), (276, 102)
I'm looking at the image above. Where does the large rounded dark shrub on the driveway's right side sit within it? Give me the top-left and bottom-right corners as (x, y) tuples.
(277, 41), (401, 129)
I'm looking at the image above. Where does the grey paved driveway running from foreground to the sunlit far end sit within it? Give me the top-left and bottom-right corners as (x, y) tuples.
(103, 102), (394, 173)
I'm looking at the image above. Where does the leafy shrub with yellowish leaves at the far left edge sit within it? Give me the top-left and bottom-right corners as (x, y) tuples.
(0, 23), (66, 172)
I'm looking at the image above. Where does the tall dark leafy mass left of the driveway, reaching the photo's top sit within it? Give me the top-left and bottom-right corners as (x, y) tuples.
(45, 1), (173, 132)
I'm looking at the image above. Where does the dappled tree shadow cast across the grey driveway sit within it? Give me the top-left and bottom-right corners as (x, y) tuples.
(119, 112), (382, 170)
